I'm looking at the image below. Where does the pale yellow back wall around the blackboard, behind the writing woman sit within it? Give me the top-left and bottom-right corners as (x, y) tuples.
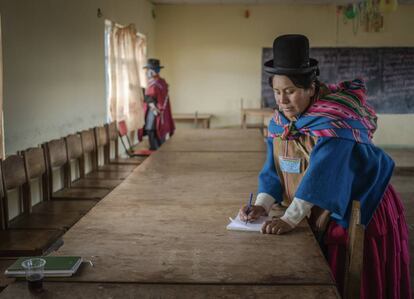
(156, 5), (414, 146)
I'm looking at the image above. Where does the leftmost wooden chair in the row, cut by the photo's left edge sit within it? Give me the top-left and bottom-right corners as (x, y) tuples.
(0, 156), (63, 256)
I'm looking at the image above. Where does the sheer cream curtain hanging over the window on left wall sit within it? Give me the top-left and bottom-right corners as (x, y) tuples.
(106, 22), (146, 131)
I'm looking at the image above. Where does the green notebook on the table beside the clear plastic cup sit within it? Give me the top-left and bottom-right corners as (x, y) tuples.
(4, 256), (82, 277)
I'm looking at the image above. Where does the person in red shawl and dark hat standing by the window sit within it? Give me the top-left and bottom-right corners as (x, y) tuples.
(144, 59), (175, 150)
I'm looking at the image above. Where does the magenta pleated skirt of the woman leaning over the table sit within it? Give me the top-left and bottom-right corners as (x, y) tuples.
(325, 185), (411, 299)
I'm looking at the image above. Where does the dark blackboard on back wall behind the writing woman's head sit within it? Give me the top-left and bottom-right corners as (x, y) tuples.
(262, 47), (414, 114)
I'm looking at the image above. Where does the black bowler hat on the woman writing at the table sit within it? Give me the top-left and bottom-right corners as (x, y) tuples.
(264, 34), (318, 75)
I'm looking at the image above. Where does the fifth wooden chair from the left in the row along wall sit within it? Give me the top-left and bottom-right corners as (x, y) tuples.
(80, 129), (130, 180)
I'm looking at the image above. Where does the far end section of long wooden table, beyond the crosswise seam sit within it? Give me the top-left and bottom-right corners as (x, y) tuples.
(160, 129), (266, 152)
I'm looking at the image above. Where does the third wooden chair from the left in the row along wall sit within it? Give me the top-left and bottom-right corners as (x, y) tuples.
(44, 138), (110, 200)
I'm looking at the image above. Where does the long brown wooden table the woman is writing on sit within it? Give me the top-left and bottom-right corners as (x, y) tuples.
(0, 130), (339, 298)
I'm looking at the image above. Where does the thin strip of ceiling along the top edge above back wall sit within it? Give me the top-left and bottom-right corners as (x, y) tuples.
(151, 0), (414, 4)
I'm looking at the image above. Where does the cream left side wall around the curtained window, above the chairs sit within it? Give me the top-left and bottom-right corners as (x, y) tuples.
(0, 0), (155, 154)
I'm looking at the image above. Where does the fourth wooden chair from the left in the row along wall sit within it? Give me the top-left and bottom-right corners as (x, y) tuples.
(65, 131), (121, 190)
